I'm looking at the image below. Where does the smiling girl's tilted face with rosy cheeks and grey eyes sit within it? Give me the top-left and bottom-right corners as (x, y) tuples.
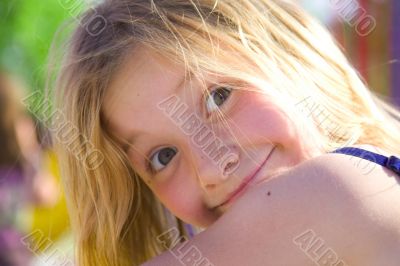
(103, 50), (313, 227)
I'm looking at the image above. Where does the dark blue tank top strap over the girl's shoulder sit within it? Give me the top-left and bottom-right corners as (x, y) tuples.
(331, 147), (400, 176)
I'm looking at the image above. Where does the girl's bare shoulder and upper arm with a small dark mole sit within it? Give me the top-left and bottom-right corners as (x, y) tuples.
(145, 154), (400, 266)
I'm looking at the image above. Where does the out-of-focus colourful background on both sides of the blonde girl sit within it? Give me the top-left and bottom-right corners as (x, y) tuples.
(0, 0), (400, 266)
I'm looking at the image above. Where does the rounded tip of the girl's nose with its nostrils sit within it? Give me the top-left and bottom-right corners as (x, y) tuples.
(191, 141), (240, 190)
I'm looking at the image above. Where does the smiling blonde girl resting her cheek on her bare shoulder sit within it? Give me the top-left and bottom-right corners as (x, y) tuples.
(54, 0), (400, 265)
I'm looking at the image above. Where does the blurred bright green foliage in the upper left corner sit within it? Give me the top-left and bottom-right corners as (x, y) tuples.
(0, 0), (84, 97)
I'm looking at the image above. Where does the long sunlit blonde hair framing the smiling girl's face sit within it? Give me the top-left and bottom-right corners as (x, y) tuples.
(51, 0), (400, 265)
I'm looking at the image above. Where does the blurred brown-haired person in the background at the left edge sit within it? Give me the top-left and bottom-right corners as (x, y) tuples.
(0, 72), (59, 266)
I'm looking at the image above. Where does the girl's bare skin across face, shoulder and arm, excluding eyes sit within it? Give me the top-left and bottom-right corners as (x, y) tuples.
(103, 50), (400, 266)
